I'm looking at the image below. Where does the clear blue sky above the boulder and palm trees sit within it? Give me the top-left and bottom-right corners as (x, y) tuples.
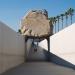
(0, 0), (75, 31)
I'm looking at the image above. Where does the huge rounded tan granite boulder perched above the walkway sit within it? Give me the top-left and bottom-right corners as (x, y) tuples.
(21, 10), (50, 37)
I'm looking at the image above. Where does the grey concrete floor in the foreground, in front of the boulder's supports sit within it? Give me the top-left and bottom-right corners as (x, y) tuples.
(2, 62), (75, 75)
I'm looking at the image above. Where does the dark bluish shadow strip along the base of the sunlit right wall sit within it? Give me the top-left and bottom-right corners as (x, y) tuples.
(44, 50), (75, 70)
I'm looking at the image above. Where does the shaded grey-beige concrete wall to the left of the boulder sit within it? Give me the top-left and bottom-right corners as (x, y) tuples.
(0, 22), (25, 73)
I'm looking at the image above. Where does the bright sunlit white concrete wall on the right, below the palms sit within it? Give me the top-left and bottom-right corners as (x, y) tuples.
(40, 23), (75, 65)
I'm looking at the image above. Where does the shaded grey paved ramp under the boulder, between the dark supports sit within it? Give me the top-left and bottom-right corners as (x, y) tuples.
(27, 47), (47, 61)
